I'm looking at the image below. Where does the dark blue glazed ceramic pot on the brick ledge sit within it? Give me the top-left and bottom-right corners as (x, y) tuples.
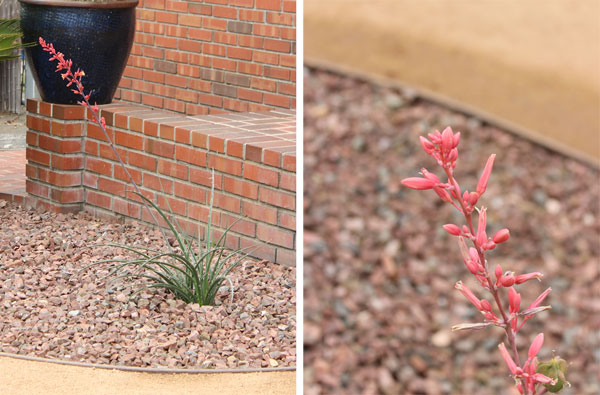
(19, 0), (138, 104)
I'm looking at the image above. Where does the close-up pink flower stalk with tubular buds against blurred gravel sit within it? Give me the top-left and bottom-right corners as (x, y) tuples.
(402, 127), (567, 395)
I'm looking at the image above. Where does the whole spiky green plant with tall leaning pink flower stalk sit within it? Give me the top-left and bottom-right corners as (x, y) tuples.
(39, 37), (252, 306)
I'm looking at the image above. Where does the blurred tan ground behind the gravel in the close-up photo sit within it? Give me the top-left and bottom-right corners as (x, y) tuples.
(304, 0), (600, 165)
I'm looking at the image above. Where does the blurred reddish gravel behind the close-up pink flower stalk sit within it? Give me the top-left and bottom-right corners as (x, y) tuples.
(304, 69), (600, 394)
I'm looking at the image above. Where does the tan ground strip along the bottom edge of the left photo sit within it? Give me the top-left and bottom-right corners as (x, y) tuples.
(0, 357), (296, 395)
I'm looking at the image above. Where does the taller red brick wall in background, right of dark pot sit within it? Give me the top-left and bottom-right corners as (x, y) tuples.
(115, 0), (296, 115)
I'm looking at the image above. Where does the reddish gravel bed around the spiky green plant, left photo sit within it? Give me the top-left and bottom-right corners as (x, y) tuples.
(0, 201), (296, 369)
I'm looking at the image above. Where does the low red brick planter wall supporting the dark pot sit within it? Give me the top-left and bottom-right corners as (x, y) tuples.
(27, 100), (296, 265)
